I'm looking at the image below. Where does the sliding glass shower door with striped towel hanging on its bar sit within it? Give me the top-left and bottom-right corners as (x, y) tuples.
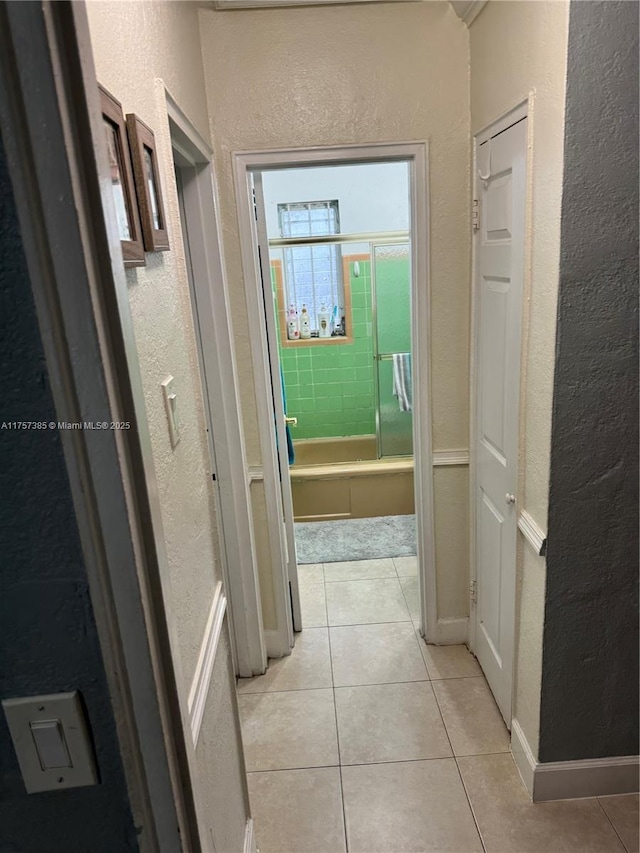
(371, 243), (413, 457)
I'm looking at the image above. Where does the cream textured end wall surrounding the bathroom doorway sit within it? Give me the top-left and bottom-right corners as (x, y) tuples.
(200, 2), (470, 627)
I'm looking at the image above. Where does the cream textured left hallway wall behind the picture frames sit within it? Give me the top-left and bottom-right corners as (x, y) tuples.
(87, 0), (248, 853)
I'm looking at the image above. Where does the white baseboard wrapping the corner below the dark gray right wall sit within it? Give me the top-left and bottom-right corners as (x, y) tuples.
(511, 720), (640, 803)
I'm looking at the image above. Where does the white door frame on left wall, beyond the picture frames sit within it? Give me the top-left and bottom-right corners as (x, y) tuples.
(168, 93), (267, 677)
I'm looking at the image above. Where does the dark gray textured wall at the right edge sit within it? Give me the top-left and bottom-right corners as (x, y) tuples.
(539, 1), (638, 761)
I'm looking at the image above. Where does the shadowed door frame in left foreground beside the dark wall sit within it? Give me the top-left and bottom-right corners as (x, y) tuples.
(0, 2), (201, 853)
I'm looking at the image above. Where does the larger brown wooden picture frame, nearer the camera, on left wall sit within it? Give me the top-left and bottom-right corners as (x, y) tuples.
(98, 86), (145, 268)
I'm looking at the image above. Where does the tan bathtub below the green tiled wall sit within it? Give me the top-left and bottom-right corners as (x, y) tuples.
(289, 435), (414, 521)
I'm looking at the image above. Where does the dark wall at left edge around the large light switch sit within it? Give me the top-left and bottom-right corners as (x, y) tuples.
(0, 130), (138, 853)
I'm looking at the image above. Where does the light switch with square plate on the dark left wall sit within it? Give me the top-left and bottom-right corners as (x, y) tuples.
(2, 690), (98, 794)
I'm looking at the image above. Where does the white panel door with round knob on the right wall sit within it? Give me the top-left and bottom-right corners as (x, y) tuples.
(474, 113), (527, 728)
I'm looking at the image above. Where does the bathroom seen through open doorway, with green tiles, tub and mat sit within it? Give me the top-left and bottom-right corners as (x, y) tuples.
(254, 161), (416, 564)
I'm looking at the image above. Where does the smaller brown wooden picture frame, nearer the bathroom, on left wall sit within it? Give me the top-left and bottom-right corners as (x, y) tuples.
(127, 113), (169, 252)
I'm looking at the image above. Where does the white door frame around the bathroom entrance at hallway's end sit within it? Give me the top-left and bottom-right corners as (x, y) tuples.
(233, 141), (439, 655)
